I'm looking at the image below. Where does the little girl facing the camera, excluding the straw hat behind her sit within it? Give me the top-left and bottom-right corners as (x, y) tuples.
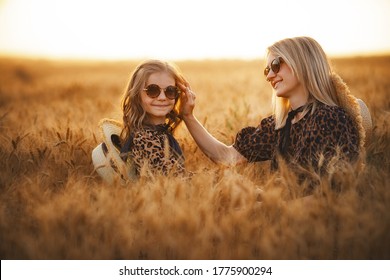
(120, 60), (185, 176)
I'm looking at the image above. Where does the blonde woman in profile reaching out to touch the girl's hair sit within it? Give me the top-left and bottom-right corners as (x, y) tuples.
(182, 37), (365, 187)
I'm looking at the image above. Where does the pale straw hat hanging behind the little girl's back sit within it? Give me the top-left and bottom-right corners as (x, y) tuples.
(92, 119), (136, 184)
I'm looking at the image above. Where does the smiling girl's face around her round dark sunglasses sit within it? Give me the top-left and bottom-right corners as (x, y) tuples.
(141, 72), (176, 125)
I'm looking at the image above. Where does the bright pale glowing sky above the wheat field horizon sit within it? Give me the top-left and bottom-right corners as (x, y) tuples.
(0, 0), (390, 60)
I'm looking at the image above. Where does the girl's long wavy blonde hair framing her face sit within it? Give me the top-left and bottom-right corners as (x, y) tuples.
(121, 60), (185, 142)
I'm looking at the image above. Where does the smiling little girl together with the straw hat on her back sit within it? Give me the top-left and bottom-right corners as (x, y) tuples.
(92, 60), (186, 183)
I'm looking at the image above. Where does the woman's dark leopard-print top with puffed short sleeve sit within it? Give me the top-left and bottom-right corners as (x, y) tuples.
(233, 104), (359, 171)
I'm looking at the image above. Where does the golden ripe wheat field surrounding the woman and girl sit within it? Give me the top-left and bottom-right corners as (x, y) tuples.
(0, 57), (390, 260)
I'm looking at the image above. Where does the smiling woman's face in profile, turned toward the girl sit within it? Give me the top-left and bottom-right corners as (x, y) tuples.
(266, 54), (304, 101)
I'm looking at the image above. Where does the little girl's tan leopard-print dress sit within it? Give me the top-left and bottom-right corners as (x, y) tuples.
(121, 125), (185, 176)
